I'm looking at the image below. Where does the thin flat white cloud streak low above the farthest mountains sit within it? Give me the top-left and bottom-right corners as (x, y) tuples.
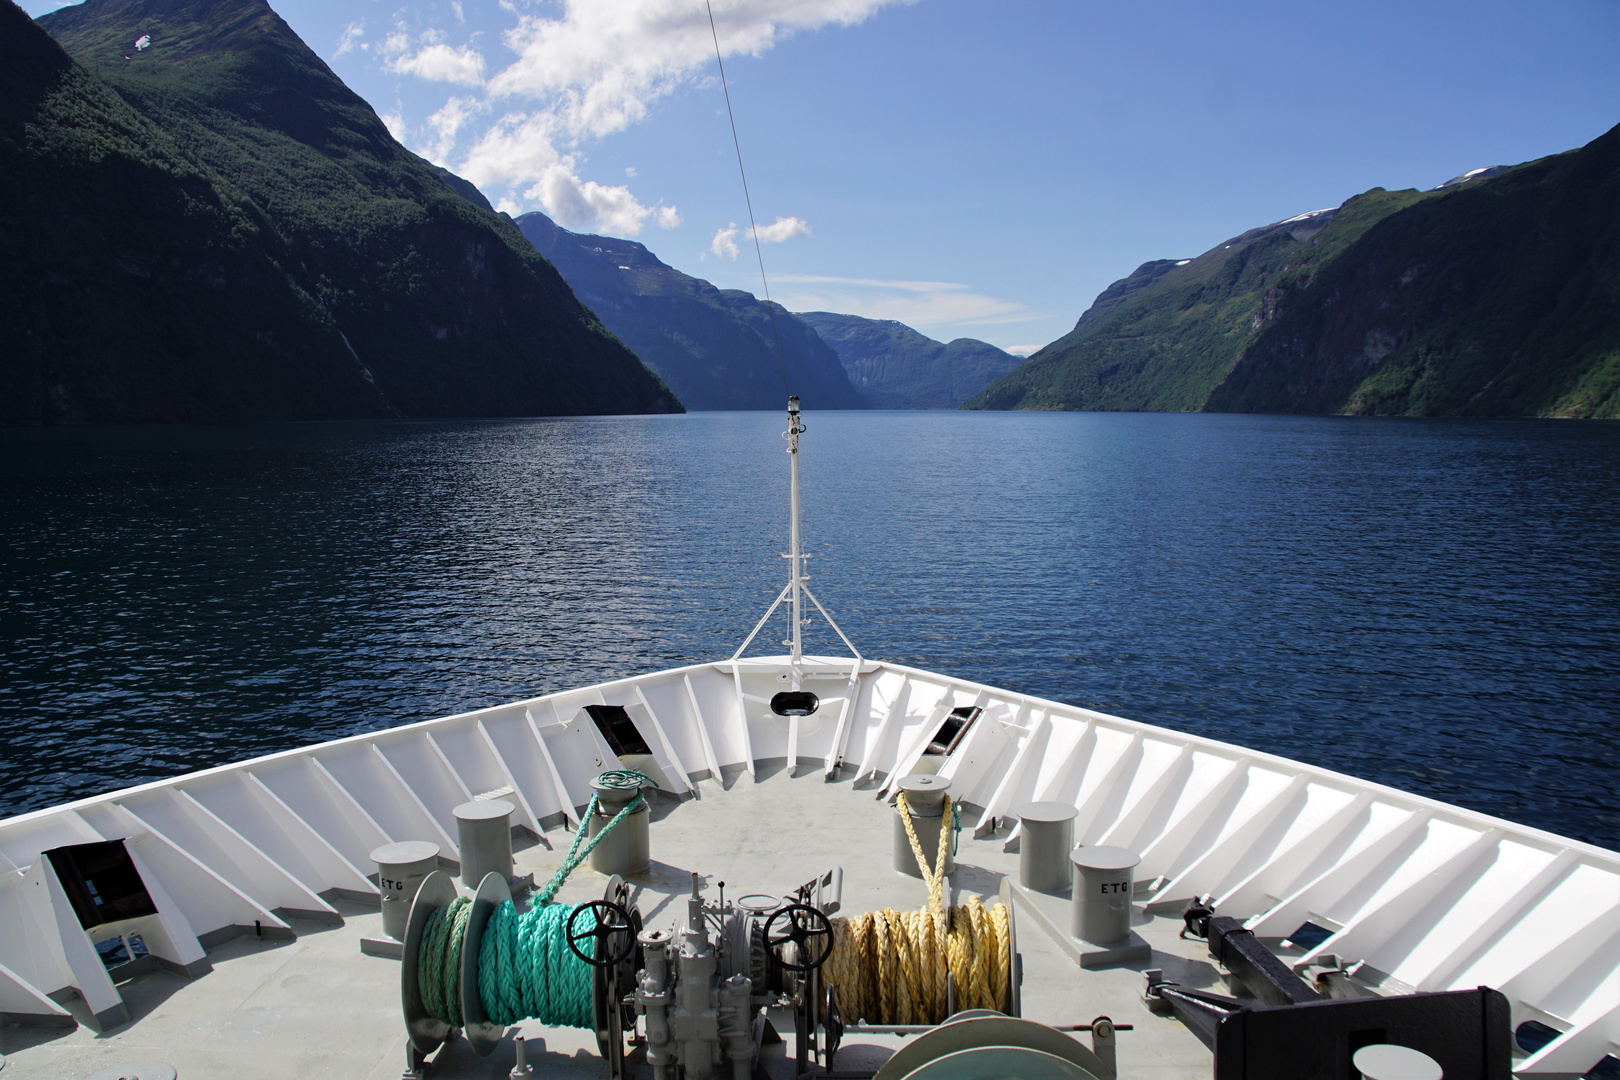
(773, 274), (1042, 329)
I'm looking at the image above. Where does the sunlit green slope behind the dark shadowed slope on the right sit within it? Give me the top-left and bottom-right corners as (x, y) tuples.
(964, 188), (1427, 411)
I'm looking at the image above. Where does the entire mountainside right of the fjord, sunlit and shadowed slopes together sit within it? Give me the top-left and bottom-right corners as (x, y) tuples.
(966, 128), (1620, 416)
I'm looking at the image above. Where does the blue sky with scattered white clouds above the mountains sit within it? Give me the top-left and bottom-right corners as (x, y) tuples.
(24, 0), (1620, 353)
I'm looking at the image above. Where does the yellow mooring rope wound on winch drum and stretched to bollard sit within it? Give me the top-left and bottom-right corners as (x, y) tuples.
(821, 792), (1013, 1023)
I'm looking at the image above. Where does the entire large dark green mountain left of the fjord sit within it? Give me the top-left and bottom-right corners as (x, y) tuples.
(0, 0), (679, 424)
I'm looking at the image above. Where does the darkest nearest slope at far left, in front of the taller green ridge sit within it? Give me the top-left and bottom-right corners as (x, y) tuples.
(0, 0), (394, 424)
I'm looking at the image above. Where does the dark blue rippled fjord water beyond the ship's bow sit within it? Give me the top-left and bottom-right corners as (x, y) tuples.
(0, 411), (1620, 847)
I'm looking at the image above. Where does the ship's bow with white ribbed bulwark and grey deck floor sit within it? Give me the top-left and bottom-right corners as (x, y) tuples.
(0, 657), (1620, 1077)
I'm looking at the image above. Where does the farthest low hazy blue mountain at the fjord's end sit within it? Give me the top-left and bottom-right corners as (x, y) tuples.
(797, 311), (1019, 408)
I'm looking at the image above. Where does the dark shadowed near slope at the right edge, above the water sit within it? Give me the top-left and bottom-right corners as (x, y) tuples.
(1207, 128), (1620, 416)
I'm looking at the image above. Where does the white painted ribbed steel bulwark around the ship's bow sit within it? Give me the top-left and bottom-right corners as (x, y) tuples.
(0, 656), (1620, 1075)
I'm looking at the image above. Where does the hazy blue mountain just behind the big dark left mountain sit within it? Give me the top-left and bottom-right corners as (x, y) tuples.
(517, 212), (863, 410)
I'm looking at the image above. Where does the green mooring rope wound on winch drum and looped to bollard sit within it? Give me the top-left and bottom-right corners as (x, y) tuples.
(416, 769), (653, 1028)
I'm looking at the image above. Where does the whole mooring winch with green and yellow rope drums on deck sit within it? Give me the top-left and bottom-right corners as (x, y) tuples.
(400, 761), (1146, 1080)
